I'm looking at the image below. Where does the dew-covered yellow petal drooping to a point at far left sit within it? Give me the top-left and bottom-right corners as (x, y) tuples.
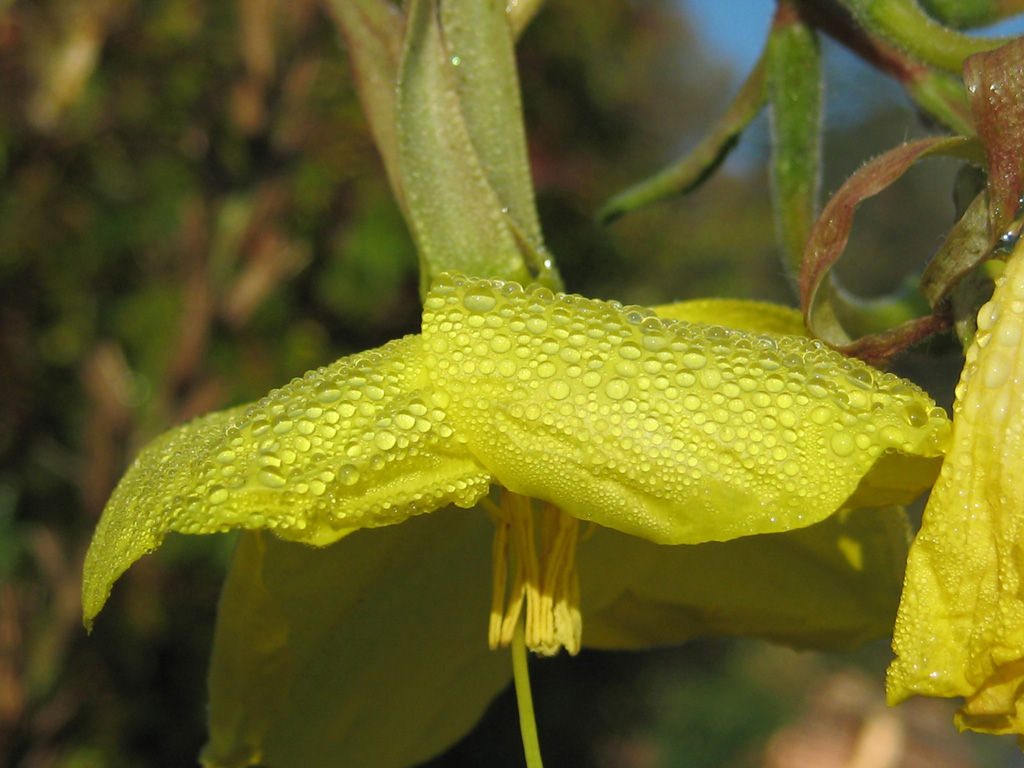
(83, 336), (492, 625)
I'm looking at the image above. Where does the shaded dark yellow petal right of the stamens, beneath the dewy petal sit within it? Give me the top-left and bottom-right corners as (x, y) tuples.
(579, 507), (909, 650)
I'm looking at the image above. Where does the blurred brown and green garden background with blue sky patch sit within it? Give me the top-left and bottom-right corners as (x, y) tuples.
(0, 0), (1024, 768)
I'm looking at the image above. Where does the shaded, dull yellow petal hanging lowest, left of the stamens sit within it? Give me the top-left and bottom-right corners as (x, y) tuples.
(203, 508), (512, 768)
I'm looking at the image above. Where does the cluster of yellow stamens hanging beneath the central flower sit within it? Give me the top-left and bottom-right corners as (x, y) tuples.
(487, 490), (583, 656)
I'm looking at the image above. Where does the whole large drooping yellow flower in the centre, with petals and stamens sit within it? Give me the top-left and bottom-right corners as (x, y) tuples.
(83, 274), (948, 767)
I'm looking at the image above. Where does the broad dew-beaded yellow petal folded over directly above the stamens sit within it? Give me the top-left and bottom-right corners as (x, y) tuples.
(423, 274), (948, 544)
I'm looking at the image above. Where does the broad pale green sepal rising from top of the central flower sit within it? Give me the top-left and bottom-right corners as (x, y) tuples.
(396, 0), (559, 293)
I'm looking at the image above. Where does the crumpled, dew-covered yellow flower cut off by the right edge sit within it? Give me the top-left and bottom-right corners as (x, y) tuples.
(888, 247), (1024, 734)
